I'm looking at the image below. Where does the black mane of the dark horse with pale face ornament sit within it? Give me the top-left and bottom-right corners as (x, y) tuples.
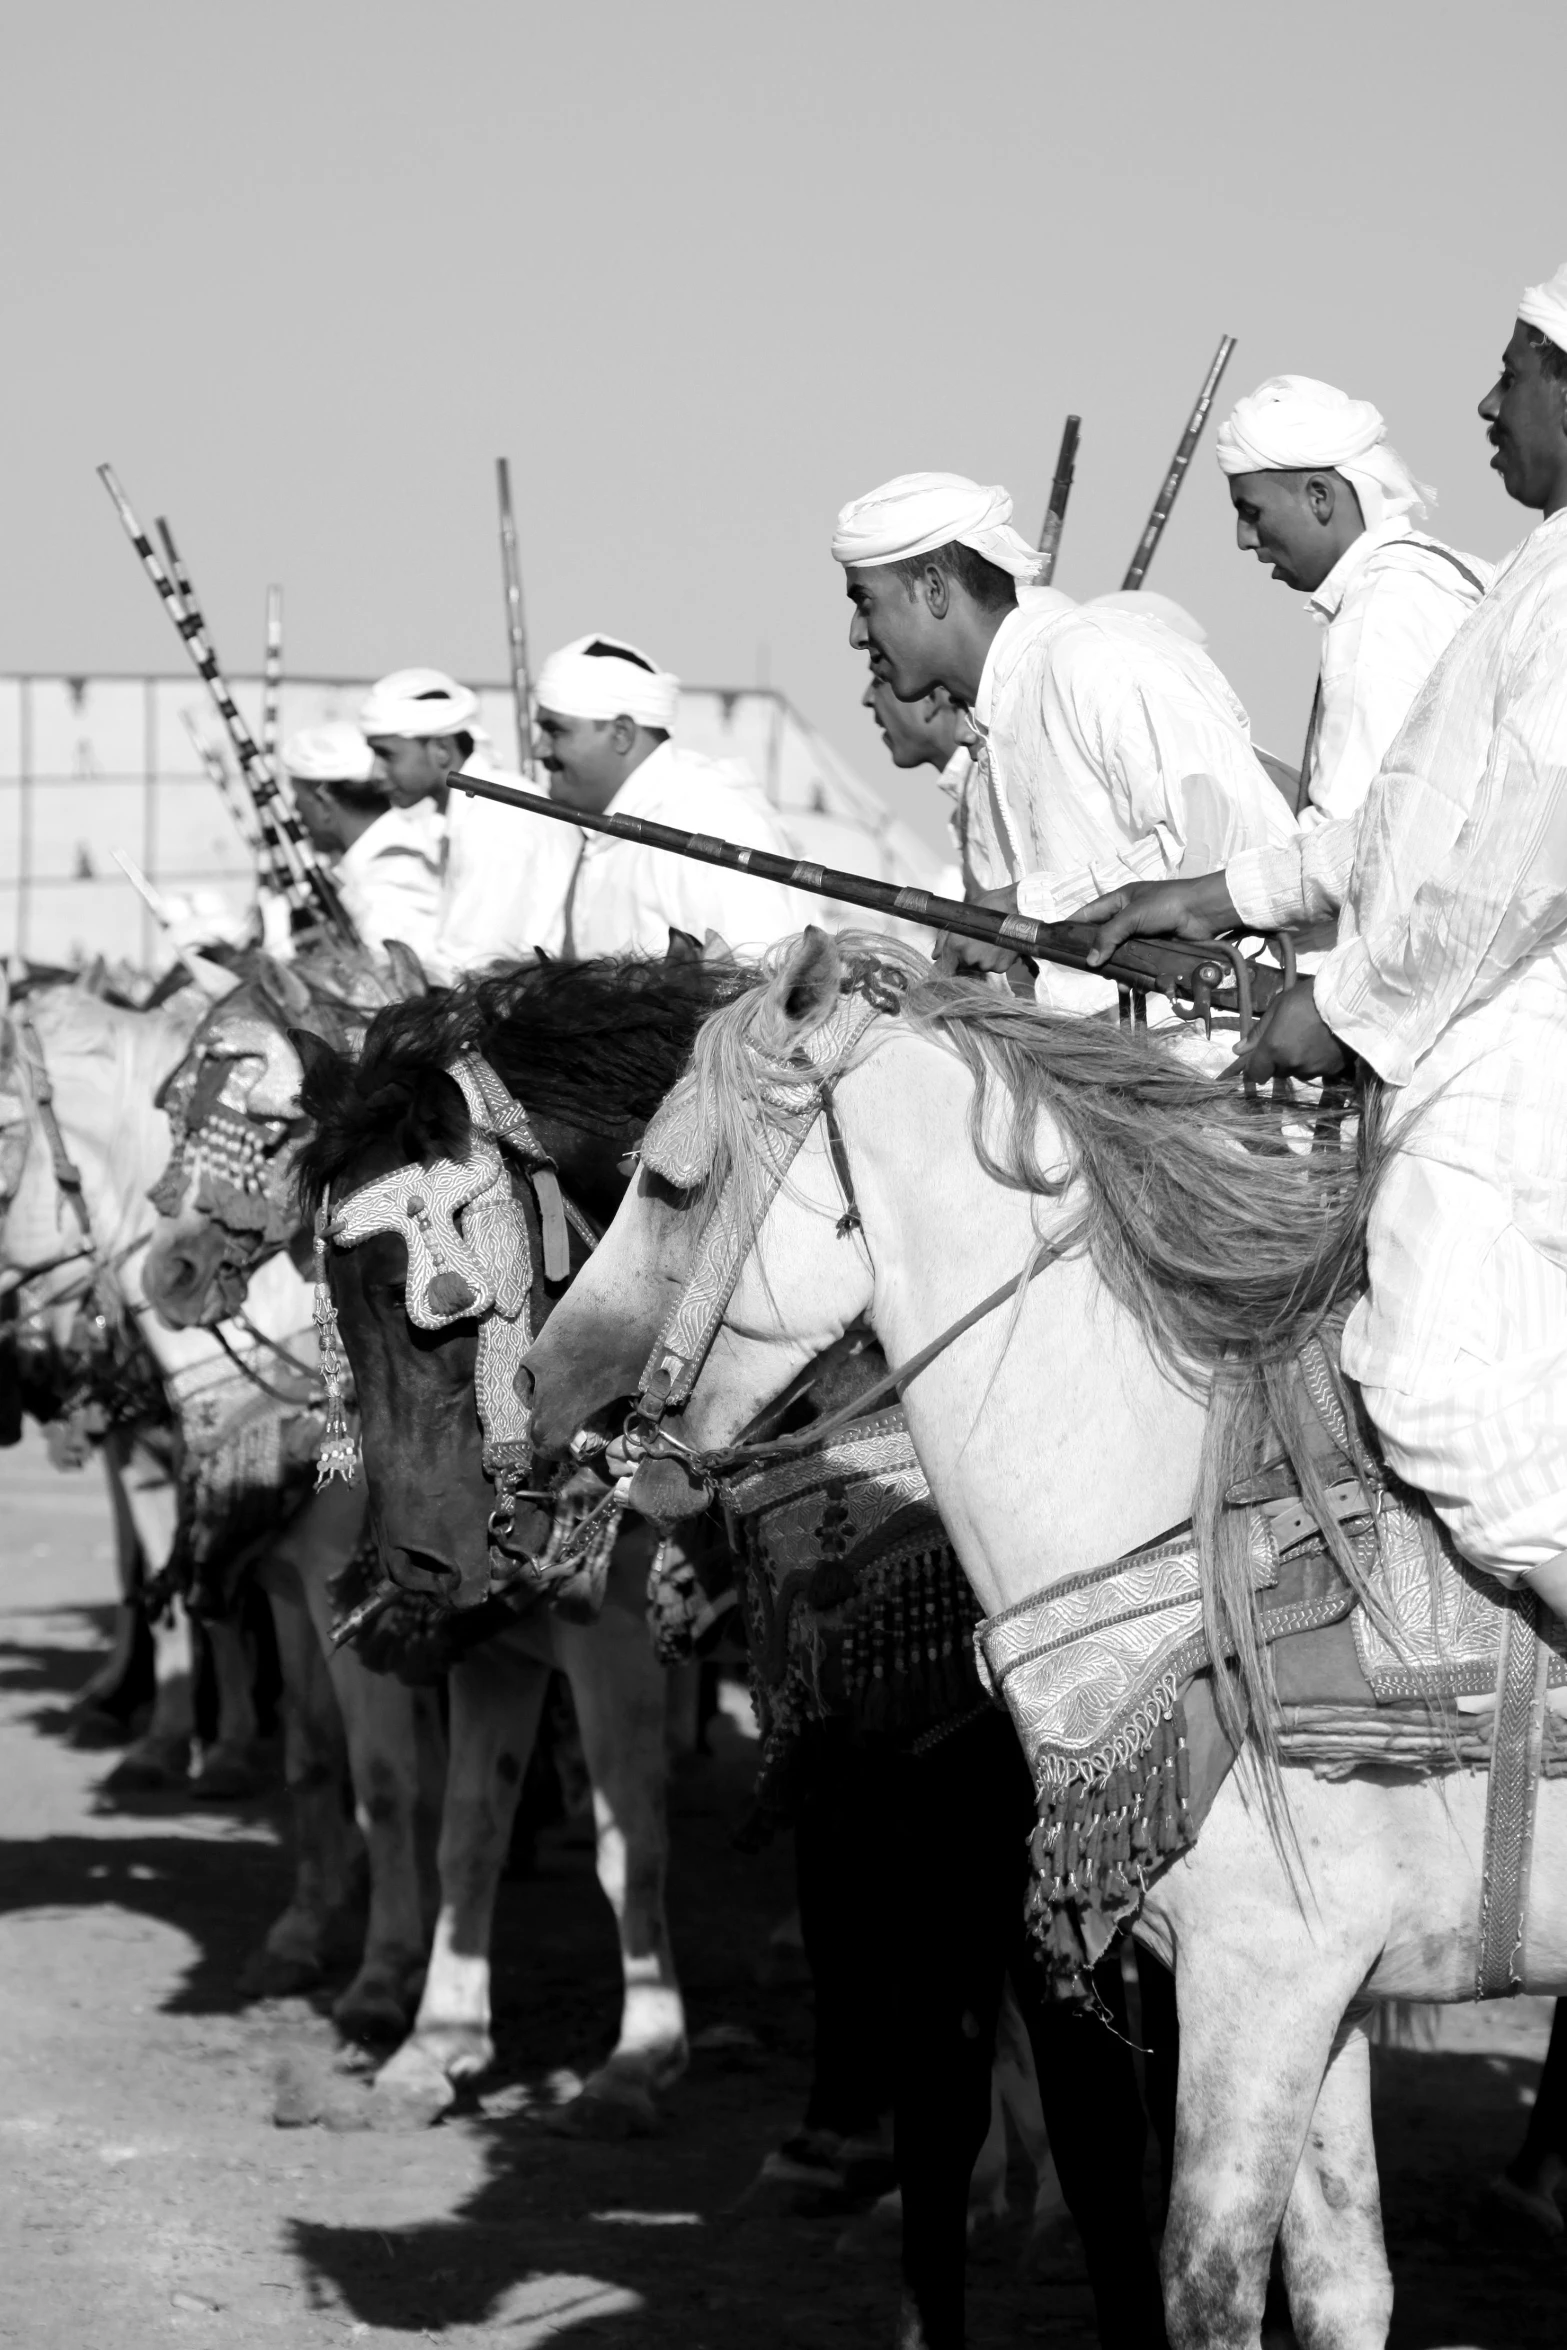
(296, 956), (754, 1213)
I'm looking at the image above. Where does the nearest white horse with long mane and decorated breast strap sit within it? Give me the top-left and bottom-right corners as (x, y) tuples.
(524, 931), (1567, 2350)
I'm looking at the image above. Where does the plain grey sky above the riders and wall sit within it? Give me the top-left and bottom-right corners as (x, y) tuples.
(0, 0), (1567, 845)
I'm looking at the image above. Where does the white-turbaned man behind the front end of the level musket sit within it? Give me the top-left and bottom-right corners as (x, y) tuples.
(535, 635), (811, 956)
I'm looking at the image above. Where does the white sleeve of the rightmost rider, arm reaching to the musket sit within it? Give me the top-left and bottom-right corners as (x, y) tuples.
(1316, 609), (1567, 1086)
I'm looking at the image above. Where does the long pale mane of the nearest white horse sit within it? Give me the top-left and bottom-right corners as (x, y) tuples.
(686, 935), (1379, 1746)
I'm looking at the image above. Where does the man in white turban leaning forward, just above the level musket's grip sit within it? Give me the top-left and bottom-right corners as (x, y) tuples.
(832, 472), (1294, 1011)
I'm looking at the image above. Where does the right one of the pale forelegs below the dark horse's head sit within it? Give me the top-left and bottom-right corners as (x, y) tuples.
(554, 1575), (686, 2120)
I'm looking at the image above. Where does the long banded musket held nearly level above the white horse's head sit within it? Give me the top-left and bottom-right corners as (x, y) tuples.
(449, 768), (1278, 1025)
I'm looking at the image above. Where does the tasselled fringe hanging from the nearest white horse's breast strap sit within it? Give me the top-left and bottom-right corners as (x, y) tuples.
(1027, 1683), (1196, 2000)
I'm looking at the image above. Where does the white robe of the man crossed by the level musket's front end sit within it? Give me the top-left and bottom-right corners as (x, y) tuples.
(561, 743), (820, 956)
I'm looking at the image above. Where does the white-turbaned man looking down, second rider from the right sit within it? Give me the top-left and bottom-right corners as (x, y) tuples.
(1217, 376), (1492, 825)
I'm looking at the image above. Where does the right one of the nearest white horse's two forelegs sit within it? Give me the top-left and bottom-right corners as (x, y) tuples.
(1283, 2016), (1393, 2350)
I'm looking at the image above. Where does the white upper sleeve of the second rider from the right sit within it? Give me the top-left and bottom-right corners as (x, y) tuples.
(1311, 541), (1471, 818)
